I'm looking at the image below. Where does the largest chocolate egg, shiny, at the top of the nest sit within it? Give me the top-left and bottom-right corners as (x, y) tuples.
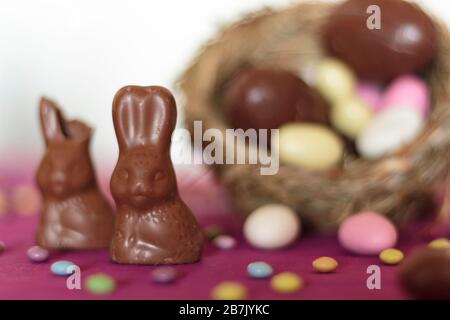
(323, 0), (437, 81)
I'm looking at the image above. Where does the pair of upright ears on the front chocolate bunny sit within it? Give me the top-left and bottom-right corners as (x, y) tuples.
(113, 86), (177, 151)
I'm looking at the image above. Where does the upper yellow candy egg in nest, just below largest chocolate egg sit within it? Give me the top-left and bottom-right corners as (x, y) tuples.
(315, 58), (356, 104)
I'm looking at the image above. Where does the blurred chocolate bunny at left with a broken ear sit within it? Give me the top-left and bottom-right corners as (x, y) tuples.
(37, 98), (114, 249)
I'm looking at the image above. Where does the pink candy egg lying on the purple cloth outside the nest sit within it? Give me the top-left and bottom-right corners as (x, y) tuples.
(338, 211), (397, 255)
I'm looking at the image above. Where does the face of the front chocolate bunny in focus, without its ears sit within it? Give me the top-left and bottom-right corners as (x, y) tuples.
(111, 147), (177, 209)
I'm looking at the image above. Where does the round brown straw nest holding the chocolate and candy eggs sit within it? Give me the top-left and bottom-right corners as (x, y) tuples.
(180, 2), (450, 230)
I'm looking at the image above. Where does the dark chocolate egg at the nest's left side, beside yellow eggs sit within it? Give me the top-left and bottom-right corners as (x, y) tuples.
(225, 69), (328, 129)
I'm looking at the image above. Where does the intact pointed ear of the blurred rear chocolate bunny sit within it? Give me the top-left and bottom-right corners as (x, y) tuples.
(39, 98), (66, 145)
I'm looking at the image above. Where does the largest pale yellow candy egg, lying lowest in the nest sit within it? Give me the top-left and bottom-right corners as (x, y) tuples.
(272, 123), (344, 170)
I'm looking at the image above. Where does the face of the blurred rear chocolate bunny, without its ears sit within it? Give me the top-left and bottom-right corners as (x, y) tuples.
(37, 143), (94, 198)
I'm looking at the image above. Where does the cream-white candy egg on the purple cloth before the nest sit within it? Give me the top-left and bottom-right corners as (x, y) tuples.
(244, 204), (301, 249)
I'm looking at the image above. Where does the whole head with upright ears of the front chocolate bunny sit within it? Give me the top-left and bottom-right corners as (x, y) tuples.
(111, 86), (177, 209)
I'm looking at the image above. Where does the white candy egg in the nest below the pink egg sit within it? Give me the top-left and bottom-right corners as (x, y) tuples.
(356, 106), (424, 159)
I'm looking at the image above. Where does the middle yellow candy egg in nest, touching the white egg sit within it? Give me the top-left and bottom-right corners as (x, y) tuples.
(331, 95), (373, 139)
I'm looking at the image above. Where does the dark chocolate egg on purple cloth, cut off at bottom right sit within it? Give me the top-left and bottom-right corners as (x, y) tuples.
(400, 248), (450, 300)
